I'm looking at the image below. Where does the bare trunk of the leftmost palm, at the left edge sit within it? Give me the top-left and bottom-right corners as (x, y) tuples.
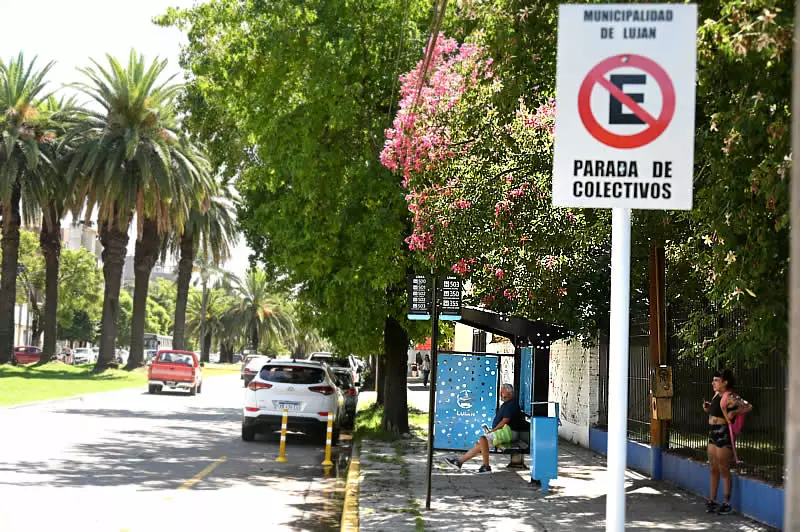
(0, 183), (22, 364)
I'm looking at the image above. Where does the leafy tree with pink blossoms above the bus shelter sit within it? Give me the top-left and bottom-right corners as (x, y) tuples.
(381, 36), (609, 332)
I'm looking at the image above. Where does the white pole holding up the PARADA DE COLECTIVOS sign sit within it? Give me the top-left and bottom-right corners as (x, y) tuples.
(606, 207), (631, 532)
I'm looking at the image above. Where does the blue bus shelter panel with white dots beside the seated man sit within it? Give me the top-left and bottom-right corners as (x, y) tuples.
(433, 354), (498, 450)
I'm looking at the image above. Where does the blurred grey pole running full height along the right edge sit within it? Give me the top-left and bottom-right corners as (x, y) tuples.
(783, 0), (800, 530)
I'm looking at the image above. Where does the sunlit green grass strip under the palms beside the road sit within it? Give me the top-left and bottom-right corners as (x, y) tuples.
(0, 363), (240, 406)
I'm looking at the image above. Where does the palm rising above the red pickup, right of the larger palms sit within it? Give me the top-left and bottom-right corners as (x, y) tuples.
(165, 184), (237, 352)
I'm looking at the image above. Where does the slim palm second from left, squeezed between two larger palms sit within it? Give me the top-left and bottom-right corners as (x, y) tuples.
(34, 96), (83, 362)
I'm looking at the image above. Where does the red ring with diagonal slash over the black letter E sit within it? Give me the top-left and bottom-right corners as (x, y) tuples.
(578, 54), (675, 149)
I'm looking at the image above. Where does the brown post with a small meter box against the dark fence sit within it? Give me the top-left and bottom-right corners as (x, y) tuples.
(649, 246), (672, 480)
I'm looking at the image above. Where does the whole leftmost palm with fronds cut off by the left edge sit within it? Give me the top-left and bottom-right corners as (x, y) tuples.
(0, 53), (53, 364)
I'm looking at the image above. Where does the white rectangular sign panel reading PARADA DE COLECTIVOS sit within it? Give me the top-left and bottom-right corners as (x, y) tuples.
(553, 4), (697, 210)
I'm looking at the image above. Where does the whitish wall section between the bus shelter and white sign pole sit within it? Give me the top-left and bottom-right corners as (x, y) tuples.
(549, 339), (600, 447)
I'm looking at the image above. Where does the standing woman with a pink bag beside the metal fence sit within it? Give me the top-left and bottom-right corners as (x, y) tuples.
(703, 369), (753, 515)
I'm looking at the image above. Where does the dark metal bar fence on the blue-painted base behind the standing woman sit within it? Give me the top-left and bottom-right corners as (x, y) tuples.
(598, 306), (787, 485)
